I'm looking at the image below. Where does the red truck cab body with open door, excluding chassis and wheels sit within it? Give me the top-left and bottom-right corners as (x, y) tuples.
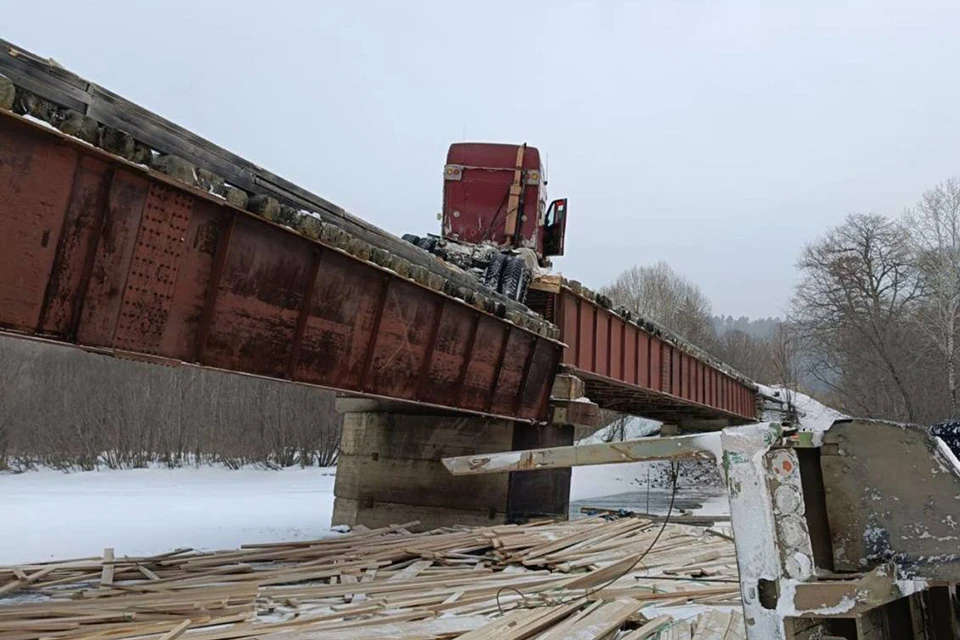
(442, 142), (567, 265)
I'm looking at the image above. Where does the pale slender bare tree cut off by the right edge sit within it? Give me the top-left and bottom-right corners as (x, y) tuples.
(905, 178), (960, 416)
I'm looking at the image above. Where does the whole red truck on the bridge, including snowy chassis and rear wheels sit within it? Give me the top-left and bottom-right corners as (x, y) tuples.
(403, 142), (567, 302)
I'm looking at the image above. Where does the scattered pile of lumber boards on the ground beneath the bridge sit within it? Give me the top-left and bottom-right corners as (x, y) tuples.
(0, 516), (743, 640)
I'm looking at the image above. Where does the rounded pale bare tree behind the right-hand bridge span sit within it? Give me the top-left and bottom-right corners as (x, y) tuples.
(601, 262), (714, 348)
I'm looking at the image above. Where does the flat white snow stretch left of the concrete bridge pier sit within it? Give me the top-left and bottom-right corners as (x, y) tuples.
(0, 466), (335, 565)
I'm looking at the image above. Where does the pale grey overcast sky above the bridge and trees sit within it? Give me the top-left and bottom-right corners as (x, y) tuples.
(7, 0), (960, 316)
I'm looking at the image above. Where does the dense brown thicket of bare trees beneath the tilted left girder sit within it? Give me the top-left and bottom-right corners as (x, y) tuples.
(0, 336), (340, 470)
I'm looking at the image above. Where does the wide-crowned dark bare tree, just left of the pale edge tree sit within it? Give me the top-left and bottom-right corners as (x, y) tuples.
(793, 215), (922, 421)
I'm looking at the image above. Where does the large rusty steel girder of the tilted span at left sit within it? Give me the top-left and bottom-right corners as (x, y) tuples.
(0, 112), (563, 421)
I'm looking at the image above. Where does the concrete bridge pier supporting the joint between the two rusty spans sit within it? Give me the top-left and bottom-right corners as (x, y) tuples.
(333, 398), (574, 528)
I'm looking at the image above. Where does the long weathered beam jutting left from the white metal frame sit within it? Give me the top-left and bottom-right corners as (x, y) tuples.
(443, 433), (720, 476)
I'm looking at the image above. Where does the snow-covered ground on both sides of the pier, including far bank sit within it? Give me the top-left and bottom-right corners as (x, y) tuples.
(0, 387), (843, 565)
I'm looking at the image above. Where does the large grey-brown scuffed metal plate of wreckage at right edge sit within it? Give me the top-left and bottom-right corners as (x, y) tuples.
(820, 420), (960, 582)
